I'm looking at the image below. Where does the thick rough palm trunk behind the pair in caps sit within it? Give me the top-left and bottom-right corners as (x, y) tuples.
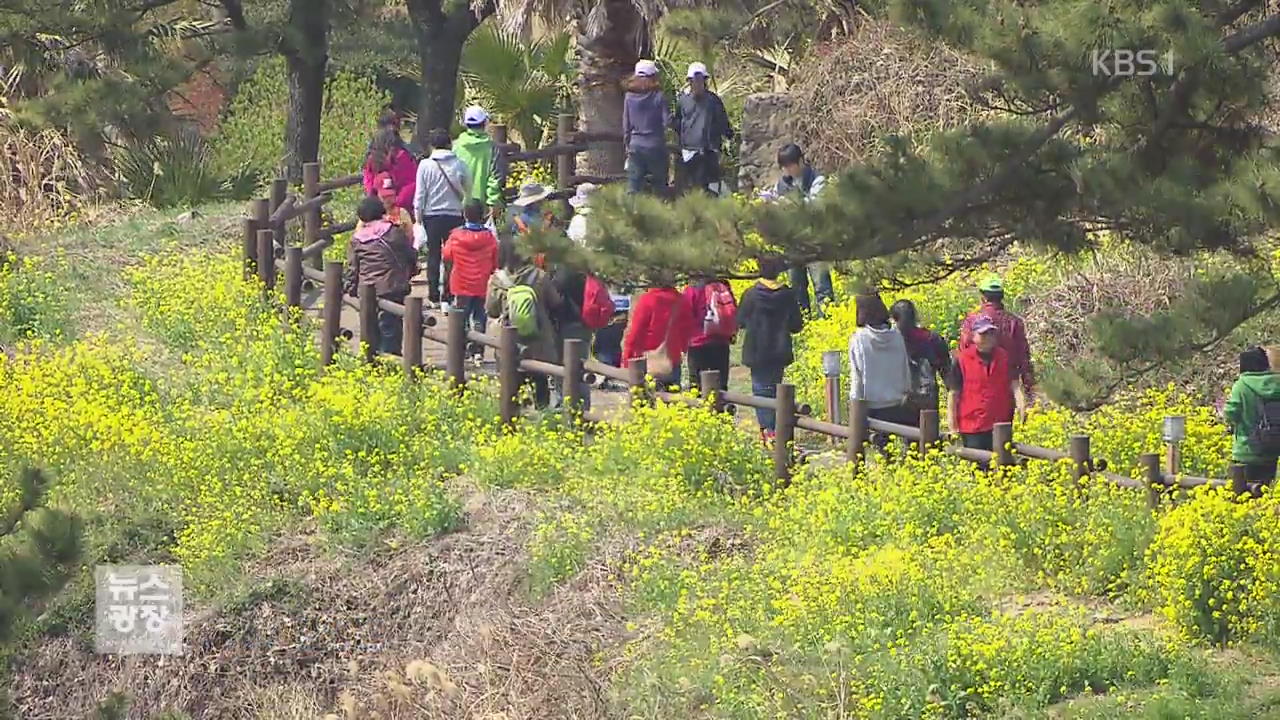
(577, 0), (646, 176)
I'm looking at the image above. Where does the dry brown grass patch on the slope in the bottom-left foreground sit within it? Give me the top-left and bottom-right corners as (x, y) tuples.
(13, 479), (626, 720)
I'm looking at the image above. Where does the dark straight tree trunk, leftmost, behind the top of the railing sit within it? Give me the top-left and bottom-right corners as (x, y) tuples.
(280, 0), (330, 183)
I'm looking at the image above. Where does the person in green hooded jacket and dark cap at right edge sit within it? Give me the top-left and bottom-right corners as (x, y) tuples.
(1222, 347), (1280, 484)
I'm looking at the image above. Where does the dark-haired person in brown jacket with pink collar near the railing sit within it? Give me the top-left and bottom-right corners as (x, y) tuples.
(347, 197), (417, 355)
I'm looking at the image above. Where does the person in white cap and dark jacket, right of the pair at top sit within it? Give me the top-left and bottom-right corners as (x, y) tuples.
(671, 63), (733, 195)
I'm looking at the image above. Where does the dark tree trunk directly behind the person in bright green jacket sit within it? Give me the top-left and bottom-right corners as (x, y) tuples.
(408, 0), (494, 150)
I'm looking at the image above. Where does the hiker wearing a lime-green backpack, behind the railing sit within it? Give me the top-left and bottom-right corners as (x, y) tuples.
(485, 241), (562, 410)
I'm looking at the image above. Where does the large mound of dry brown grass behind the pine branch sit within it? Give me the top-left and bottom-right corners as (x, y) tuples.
(791, 17), (982, 168)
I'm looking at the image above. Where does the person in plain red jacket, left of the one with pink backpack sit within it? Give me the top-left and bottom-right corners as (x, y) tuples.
(622, 271), (694, 388)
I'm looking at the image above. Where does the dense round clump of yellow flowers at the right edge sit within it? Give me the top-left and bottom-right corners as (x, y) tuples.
(1147, 488), (1280, 643)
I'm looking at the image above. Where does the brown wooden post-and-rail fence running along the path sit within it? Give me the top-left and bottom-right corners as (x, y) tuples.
(243, 165), (1248, 507)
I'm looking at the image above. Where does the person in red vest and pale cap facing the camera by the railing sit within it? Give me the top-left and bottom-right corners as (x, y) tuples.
(947, 315), (1025, 451)
